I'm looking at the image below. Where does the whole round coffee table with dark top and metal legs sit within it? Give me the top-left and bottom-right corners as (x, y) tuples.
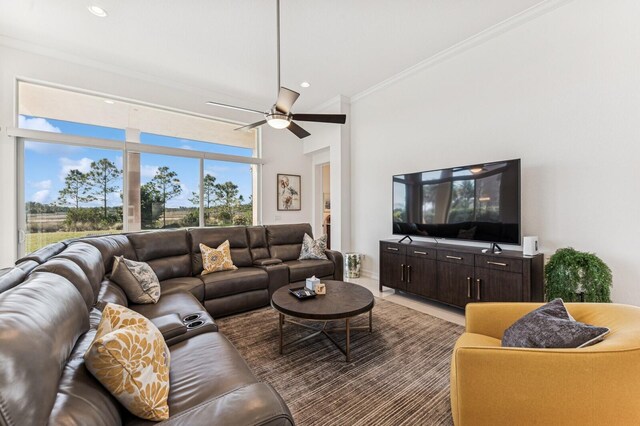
(271, 280), (374, 362)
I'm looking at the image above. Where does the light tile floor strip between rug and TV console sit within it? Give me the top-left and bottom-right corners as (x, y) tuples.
(345, 277), (464, 325)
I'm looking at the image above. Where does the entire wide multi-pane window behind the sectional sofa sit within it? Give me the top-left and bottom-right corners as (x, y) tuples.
(15, 82), (261, 253)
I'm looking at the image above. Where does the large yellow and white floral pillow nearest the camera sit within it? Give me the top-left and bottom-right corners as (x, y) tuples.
(84, 303), (169, 421)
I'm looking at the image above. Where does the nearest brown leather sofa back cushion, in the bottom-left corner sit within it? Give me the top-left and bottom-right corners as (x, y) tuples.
(0, 272), (89, 425)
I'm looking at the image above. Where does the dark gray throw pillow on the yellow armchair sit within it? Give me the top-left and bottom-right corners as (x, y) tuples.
(502, 299), (609, 348)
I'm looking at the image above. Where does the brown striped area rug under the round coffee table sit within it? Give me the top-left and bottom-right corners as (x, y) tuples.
(216, 299), (463, 426)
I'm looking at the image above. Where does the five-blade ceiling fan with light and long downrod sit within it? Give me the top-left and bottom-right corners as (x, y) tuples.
(207, 0), (347, 139)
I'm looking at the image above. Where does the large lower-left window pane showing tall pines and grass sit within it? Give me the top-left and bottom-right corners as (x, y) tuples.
(24, 141), (122, 253)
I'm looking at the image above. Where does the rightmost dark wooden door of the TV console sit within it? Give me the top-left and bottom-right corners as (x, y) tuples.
(473, 268), (524, 302)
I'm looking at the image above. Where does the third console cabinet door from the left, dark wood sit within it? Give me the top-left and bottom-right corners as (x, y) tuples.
(437, 262), (474, 308)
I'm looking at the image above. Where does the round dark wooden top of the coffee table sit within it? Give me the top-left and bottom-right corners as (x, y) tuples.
(271, 280), (374, 320)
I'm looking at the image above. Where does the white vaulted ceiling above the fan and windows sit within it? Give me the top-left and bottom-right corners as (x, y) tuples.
(0, 0), (541, 110)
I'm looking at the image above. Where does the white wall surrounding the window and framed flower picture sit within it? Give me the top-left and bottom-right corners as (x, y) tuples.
(0, 44), (311, 267)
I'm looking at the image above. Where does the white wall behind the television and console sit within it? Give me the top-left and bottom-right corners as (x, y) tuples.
(351, 0), (640, 305)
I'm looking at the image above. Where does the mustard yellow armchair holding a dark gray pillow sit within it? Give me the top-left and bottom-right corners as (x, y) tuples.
(451, 303), (640, 426)
